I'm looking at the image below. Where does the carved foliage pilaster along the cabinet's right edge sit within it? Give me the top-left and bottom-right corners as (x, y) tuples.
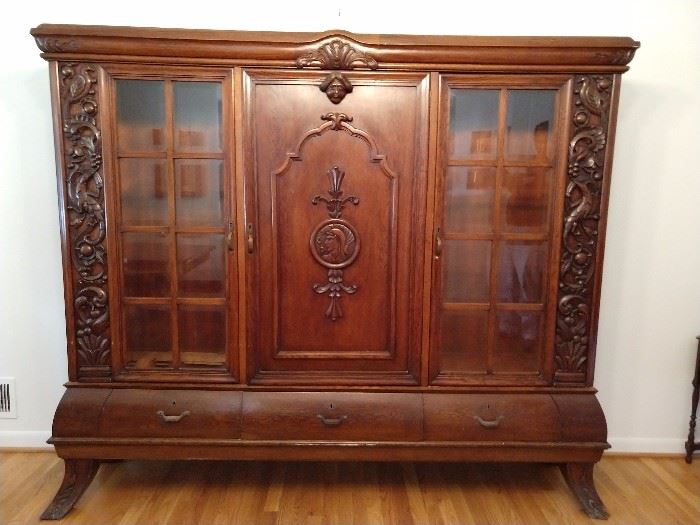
(554, 75), (613, 384)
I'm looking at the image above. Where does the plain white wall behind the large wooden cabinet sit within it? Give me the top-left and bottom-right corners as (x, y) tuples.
(0, 0), (700, 452)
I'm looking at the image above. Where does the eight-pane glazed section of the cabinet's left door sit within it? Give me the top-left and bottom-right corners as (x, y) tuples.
(115, 72), (235, 372)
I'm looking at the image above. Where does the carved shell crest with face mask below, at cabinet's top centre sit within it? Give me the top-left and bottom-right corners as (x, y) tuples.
(297, 38), (379, 104)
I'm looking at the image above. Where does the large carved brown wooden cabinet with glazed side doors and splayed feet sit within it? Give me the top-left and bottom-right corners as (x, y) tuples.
(31, 25), (639, 519)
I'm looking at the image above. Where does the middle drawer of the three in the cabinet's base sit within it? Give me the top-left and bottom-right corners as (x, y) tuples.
(242, 392), (422, 441)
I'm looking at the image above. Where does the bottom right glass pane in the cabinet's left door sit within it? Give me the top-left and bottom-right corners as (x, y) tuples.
(178, 305), (226, 366)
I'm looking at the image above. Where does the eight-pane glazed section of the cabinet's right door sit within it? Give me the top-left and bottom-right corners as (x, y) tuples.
(430, 77), (563, 383)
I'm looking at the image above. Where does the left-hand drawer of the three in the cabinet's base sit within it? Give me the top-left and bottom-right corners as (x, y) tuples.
(101, 389), (241, 439)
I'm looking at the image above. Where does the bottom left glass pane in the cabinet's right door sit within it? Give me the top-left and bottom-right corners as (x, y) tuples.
(440, 310), (488, 372)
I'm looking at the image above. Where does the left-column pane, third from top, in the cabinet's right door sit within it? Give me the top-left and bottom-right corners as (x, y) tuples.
(442, 240), (491, 303)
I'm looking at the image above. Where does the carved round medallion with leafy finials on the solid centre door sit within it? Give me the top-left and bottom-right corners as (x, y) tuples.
(309, 166), (360, 321)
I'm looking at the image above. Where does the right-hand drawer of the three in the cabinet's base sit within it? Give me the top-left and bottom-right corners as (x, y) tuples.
(424, 394), (561, 441)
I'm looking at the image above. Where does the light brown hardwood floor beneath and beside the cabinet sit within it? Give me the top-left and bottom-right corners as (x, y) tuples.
(0, 452), (700, 525)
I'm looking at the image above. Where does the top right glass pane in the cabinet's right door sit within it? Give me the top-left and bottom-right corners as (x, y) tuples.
(506, 89), (556, 162)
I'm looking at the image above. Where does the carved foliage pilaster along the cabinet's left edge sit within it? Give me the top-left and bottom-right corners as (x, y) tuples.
(59, 63), (111, 378)
